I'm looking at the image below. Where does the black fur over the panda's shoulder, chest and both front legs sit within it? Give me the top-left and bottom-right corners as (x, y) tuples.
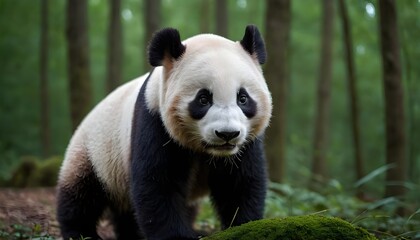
(130, 71), (266, 239)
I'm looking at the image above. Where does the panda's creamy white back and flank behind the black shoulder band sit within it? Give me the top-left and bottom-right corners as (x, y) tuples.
(60, 72), (147, 203)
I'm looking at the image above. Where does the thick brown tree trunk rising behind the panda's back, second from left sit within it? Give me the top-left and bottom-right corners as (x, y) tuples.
(66, 0), (92, 131)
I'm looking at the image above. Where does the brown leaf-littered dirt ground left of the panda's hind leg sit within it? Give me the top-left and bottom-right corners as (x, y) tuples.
(0, 188), (113, 239)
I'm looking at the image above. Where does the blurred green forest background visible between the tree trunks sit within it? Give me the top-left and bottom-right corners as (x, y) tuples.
(0, 0), (420, 212)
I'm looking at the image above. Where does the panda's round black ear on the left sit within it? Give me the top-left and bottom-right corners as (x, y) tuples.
(148, 28), (186, 67)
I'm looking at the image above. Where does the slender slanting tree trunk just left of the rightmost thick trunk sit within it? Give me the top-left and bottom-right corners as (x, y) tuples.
(339, 0), (364, 197)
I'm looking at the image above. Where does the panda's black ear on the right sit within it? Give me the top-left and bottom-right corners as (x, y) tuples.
(241, 25), (267, 64)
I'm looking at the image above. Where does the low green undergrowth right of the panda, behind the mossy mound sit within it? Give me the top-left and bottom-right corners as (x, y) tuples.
(265, 183), (420, 239)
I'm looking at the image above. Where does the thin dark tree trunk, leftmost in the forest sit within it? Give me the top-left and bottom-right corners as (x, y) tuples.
(39, 0), (51, 157)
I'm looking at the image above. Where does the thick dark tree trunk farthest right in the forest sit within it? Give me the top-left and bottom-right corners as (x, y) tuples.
(379, 0), (406, 215)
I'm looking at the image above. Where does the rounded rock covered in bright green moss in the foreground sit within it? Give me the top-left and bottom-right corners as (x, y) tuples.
(203, 215), (377, 240)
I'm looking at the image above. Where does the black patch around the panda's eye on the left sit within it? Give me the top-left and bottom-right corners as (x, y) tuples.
(188, 89), (213, 120)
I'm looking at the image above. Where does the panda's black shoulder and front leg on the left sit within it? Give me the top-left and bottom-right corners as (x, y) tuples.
(131, 74), (198, 240)
